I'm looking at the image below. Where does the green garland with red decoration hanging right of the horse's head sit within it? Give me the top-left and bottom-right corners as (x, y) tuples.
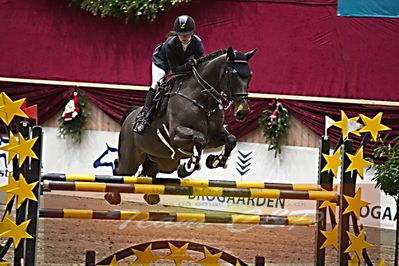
(259, 102), (289, 157)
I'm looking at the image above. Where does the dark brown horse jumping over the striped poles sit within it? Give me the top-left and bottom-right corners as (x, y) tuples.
(105, 47), (256, 204)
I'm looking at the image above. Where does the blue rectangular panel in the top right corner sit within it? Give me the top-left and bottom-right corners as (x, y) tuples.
(338, 0), (399, 18)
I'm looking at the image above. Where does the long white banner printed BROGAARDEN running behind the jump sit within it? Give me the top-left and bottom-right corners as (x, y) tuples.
(0, 127), (397, 229)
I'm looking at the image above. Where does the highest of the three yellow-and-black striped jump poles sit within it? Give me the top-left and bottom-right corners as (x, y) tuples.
(42, 174), (321, 190)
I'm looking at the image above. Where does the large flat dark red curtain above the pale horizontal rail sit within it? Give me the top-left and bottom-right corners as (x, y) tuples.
(0, 0), (399, 101)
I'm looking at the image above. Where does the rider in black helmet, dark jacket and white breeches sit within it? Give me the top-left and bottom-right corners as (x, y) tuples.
(133, 15), (204, 135)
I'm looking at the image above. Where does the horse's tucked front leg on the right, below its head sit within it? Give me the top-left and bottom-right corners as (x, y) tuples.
(206, 132), (237, 169)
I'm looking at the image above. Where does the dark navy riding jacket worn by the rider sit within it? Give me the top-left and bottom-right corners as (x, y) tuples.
(152, 35), (204, 73)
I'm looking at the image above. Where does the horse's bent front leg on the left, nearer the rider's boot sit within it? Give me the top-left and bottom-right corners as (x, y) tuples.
(173, 126), (206, 178)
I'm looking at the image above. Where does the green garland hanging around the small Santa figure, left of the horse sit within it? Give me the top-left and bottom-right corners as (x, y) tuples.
(57, 92), (91, 143)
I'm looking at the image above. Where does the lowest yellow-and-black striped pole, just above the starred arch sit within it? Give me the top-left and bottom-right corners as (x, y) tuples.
(39, 209), (315, 226)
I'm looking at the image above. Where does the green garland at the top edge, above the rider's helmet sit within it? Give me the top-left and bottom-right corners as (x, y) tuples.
(70, 0), (191, 22)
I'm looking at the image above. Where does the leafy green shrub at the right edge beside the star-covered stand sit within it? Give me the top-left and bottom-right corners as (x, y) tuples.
(372, 135), (399, 202)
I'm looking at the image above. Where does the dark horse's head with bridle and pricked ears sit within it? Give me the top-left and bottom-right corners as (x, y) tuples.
(223, 47), (256, 121)
